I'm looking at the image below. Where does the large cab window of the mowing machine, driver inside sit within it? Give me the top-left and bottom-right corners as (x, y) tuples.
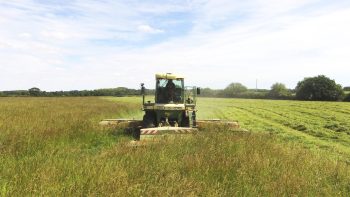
(156, 79), (184, 103)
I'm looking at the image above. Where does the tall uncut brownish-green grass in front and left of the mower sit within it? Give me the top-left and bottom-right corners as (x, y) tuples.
(0, 98), (350, 196)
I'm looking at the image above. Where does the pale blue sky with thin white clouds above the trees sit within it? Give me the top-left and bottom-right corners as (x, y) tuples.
(0, 0), (350, 91)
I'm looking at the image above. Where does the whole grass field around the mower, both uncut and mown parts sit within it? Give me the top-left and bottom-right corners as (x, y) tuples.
(0, 97), (350, 196)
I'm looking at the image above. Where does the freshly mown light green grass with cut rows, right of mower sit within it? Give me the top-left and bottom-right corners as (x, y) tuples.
(199, 99), (350, 161)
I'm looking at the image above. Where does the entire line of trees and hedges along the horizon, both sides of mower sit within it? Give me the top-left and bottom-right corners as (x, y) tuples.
(0, 75), (350, 101)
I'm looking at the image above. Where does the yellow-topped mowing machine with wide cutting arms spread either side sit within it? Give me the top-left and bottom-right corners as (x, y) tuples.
(100, 73), (239, 140)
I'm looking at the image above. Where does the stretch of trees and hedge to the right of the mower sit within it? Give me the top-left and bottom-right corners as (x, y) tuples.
(201, 75), (350, 101)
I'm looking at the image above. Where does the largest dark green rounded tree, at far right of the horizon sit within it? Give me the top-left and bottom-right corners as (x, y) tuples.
(296, 75), (344, 101)
